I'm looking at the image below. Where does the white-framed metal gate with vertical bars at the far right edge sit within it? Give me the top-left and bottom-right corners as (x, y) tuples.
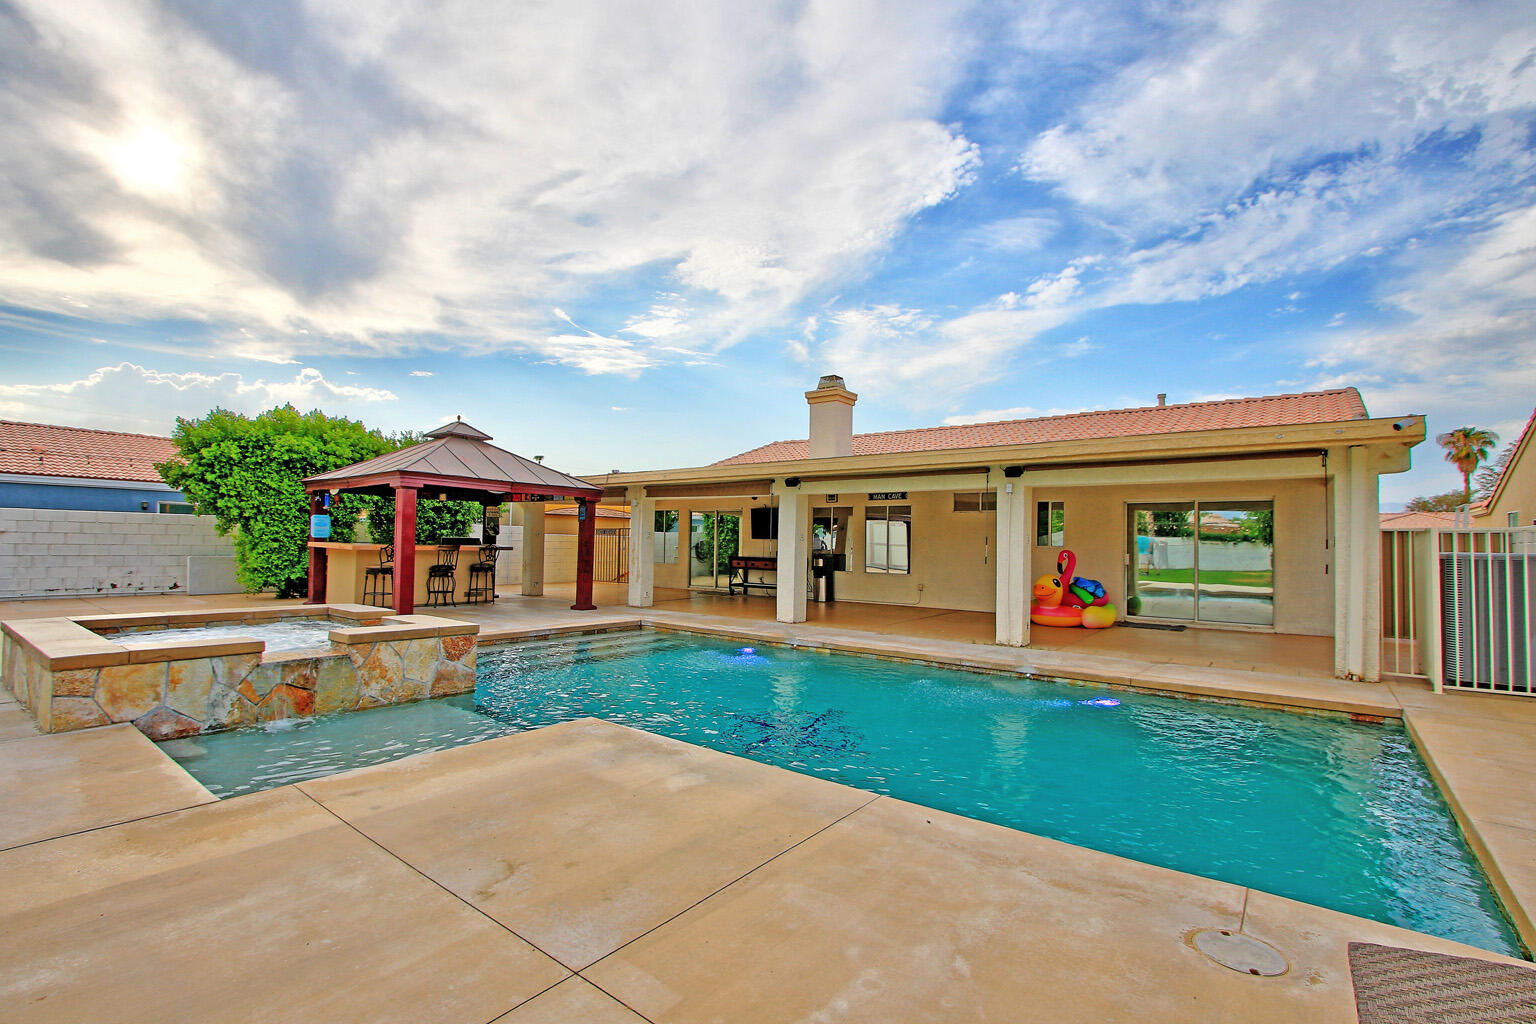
(1433, 527), (1536, 697)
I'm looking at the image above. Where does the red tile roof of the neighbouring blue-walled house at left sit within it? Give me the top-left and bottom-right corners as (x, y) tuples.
(0, 419), (177, 484)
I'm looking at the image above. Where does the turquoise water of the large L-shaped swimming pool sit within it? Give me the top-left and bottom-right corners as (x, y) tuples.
(167, 633), (1519, 955)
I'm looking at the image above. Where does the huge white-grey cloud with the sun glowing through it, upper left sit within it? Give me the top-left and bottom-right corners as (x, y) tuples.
(0, 0), (978, 373)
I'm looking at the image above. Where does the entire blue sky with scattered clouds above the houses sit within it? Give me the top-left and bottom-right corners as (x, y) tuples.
(0, 0), (1536, 507)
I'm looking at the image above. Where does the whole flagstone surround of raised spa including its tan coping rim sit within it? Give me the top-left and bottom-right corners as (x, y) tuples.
(0, 608), (479, 740)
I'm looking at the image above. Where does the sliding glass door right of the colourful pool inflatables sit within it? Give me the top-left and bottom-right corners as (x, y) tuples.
(1126, 502), (1275, 626)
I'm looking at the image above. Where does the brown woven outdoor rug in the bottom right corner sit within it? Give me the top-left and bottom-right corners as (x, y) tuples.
(1349, 943), (1536, 1024)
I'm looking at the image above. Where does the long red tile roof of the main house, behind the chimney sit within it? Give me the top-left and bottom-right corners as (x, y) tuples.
(714, 387), (1369, 465)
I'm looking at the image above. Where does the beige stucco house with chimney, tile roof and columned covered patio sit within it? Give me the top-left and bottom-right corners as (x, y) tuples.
(591, 376), (1424, 679)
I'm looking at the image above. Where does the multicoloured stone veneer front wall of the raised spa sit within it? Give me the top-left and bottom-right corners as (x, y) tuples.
(0, 626), (476, 740)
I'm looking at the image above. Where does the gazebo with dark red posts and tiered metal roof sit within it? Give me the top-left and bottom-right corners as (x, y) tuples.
(304, 419), (602, 616)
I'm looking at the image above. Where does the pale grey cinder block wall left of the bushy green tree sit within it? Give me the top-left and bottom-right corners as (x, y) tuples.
(0, 508), (235, 600)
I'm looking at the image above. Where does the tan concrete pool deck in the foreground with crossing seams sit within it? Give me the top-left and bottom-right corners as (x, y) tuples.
(0, 720), (1529, 1024)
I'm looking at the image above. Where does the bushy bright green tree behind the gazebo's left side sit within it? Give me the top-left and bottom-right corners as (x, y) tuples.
(155, 405), (390, 597)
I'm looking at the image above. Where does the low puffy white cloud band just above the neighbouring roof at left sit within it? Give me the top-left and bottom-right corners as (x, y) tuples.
(0, 362), (395, 433)
